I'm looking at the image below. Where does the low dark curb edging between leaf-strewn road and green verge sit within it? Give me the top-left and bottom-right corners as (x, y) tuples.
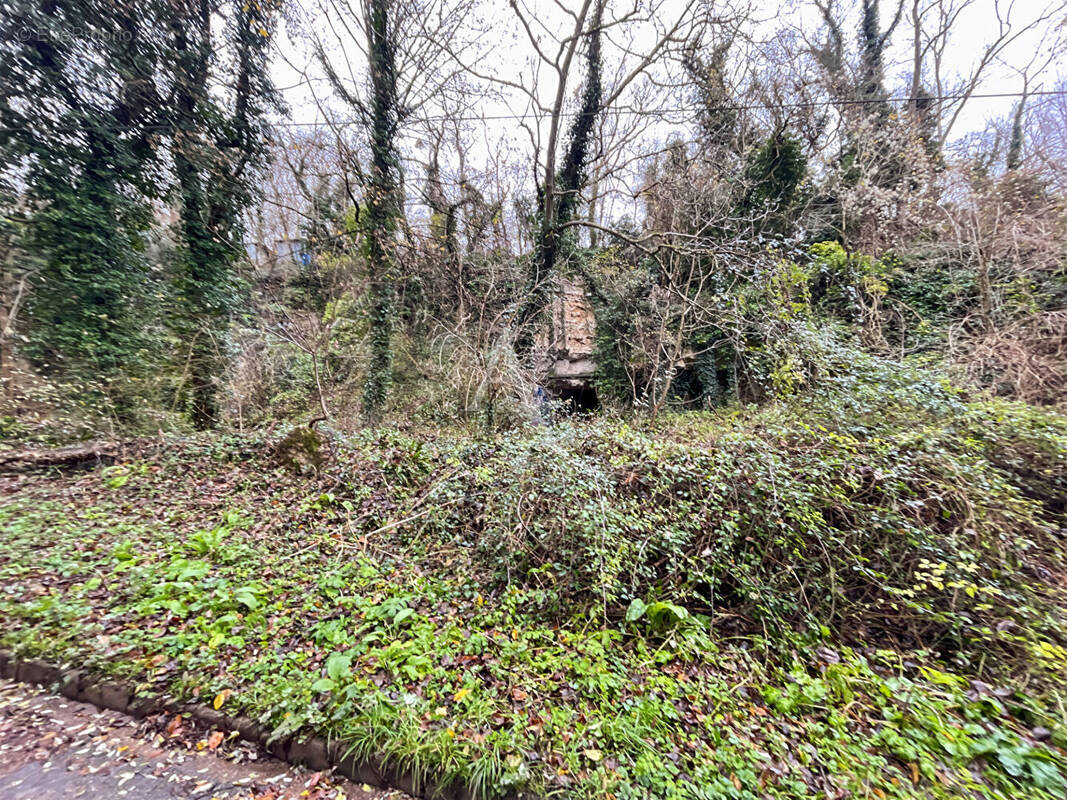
(0, 650), (474, 800)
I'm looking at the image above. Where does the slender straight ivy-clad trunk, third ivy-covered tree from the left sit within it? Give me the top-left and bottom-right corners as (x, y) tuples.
(363, 0), (400, 419)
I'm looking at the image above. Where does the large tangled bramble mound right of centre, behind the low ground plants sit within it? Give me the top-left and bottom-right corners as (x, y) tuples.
(352, 358), (1067, 691)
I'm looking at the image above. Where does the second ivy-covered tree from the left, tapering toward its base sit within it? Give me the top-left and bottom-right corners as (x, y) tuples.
(171, 0), (276, 429)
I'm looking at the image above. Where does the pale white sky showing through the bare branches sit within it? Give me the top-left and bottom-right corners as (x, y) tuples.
(262, 0), (1067, 228)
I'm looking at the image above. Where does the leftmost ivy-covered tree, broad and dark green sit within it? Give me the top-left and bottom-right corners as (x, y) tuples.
(8, 2), (159, 401)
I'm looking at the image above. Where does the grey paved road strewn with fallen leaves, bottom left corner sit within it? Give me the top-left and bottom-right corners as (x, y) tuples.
(0, 681), (410, 800)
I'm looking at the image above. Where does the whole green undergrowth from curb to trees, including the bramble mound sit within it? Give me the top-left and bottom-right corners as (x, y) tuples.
(0, 371), (1067, 799)
